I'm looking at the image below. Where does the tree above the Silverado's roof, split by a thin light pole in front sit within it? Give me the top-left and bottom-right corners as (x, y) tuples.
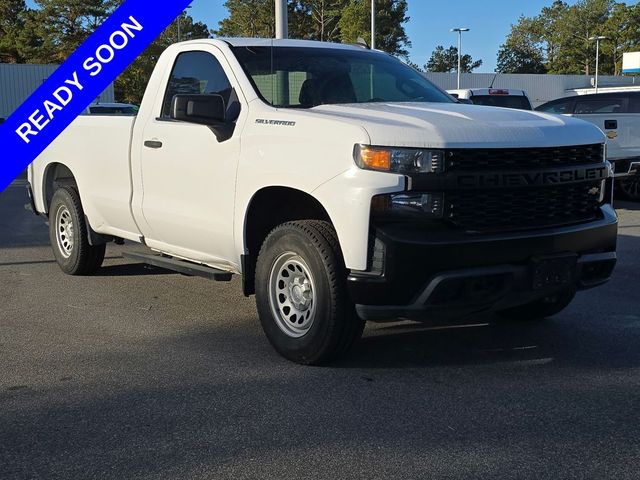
(338, 0), (411, 58)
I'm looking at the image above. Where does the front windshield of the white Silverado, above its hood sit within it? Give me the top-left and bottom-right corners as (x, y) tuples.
(233, 47), (454, 108)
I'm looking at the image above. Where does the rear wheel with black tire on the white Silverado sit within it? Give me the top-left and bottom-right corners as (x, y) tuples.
(49, 187), (106, 275)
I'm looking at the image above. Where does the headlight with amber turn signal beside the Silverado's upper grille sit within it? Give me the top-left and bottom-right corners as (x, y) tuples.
(353, 145), (444, 175)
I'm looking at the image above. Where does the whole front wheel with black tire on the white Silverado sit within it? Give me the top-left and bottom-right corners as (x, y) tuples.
(256, 220), (365, 365)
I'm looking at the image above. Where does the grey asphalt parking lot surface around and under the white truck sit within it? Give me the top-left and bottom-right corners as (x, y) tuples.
(0, 181), (640, 480)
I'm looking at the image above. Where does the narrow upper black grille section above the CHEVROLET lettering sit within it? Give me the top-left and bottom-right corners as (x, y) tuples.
(446, 144), (604, 172)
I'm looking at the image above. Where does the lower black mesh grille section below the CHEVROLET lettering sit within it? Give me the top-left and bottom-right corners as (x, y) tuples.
(445, 181), (602, 233)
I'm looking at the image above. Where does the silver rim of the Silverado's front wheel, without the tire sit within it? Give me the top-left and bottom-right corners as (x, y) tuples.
(269, 252), (316, 338)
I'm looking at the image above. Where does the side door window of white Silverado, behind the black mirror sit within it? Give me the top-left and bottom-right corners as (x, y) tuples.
(162, 52), (231, 118)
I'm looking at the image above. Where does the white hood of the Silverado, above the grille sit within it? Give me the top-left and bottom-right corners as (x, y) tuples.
(311, 103), (605, 148)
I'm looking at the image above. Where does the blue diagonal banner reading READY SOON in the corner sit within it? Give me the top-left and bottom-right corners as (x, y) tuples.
(0, 0), (192, 192)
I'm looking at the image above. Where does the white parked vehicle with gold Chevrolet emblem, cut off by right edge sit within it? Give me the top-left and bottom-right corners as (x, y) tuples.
(536, 92), (640, 201)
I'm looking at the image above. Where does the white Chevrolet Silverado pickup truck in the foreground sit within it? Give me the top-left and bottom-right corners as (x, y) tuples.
(29, 39), (617, 364)
